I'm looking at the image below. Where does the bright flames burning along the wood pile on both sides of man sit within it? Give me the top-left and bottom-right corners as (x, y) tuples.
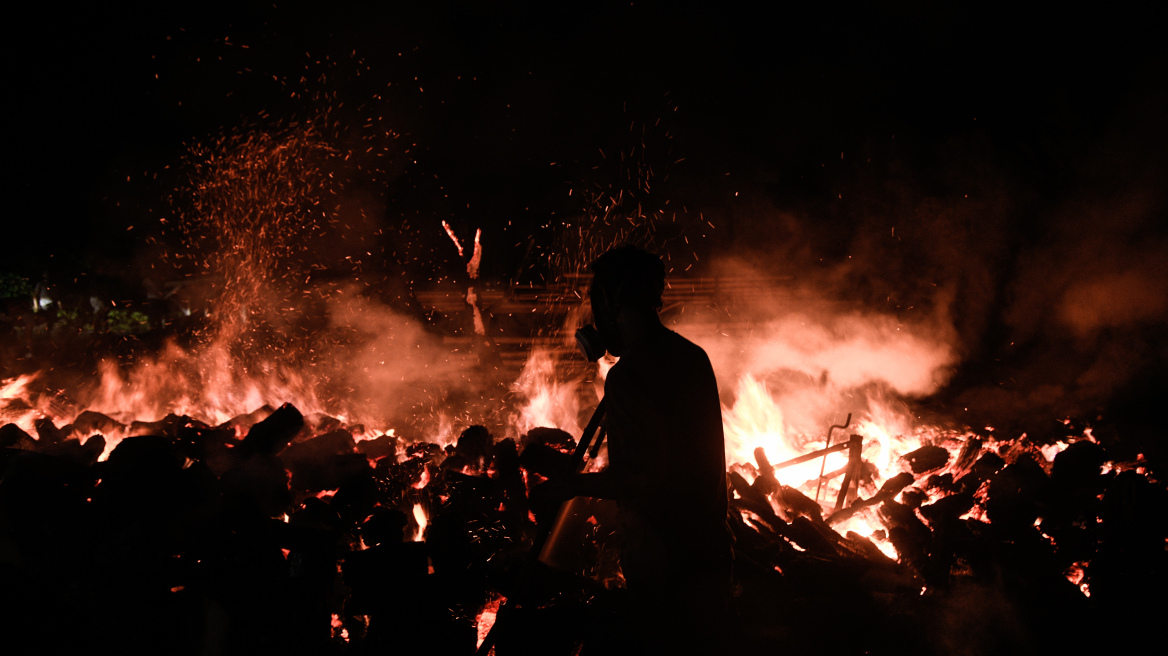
(0, 283), (1107, 558)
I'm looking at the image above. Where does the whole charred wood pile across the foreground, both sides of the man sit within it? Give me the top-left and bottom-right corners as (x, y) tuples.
(0, 396), (1168, 655)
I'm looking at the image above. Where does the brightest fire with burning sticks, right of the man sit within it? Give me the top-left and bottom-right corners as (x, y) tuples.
(723, 374), (982, 558)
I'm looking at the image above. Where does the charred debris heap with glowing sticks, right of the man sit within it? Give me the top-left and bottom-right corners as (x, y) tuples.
(730, 435), (1168, 654)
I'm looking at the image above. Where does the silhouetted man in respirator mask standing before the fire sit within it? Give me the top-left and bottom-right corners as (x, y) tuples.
(566, 246), (734, 654)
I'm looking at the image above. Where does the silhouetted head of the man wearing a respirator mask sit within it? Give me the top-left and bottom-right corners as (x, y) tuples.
(590, 246), (665, 356)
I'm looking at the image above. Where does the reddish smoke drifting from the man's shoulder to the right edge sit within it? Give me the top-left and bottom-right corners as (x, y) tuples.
(675, 68), (1168, 435)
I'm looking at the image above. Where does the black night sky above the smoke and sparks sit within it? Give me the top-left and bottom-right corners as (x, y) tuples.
(6, 2), (1164, 273)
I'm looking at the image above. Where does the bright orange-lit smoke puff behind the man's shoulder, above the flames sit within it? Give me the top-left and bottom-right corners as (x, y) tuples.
(674, 253), (958, 435)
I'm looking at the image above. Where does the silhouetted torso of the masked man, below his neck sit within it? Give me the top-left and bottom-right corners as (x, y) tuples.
(605, 327), (734, 579)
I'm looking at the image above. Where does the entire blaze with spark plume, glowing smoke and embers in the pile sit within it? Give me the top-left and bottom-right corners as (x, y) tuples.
(0, 81), (1145, 644)
